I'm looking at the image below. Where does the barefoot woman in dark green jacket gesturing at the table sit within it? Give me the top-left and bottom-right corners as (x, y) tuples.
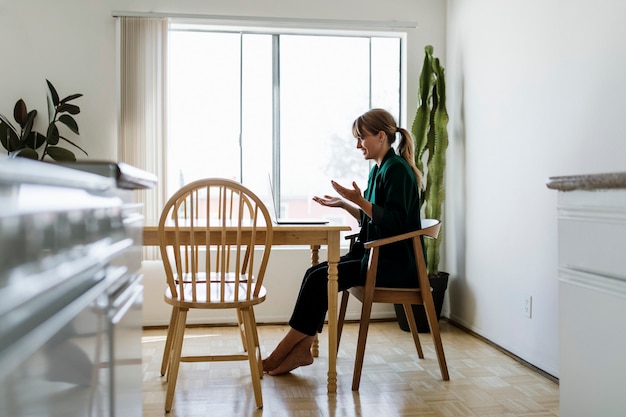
(263, 109), (421, 375)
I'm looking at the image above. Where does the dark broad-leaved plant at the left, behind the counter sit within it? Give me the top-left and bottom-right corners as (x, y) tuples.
(0, 80), (87, 162)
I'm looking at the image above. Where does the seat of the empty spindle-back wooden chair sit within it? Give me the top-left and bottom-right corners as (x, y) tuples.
(164, 281), (267, 309)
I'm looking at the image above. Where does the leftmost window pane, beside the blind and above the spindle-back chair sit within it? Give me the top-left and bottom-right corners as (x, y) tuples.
(166, 31), (241, 195)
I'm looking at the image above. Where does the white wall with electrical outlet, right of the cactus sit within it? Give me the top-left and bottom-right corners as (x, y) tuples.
(446, 0), (626, 376)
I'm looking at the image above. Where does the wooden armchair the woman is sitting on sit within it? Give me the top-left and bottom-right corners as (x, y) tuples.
(337, 219), (450, 391)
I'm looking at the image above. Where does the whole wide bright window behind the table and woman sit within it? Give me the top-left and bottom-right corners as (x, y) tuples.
(166, 24), (402, 237)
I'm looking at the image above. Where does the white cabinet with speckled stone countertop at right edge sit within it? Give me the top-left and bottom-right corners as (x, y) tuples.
(548, 173), (626, 417)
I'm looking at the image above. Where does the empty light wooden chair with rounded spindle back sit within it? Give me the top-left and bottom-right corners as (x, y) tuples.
(158, 178), (272, 412)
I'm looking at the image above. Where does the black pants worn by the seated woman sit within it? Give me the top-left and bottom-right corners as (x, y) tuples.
(289, 244), (365, 336)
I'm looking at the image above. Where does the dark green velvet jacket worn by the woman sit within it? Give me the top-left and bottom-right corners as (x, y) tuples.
(359, 148), (421, 287)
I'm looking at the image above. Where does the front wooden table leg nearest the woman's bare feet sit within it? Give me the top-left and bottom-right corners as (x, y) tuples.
(328, 232), (339, 393)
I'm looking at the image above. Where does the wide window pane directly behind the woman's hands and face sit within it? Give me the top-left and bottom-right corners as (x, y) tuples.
(275, 35), (370, 231)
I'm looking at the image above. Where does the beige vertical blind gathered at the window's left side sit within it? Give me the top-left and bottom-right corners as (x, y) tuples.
(118, 17), (169, 259)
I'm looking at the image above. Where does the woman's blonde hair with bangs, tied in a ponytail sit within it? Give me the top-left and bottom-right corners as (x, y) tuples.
(352, 109), (422, 188)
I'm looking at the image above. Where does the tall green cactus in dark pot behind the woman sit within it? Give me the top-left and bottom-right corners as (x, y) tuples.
(395, 45), (449, 332)
